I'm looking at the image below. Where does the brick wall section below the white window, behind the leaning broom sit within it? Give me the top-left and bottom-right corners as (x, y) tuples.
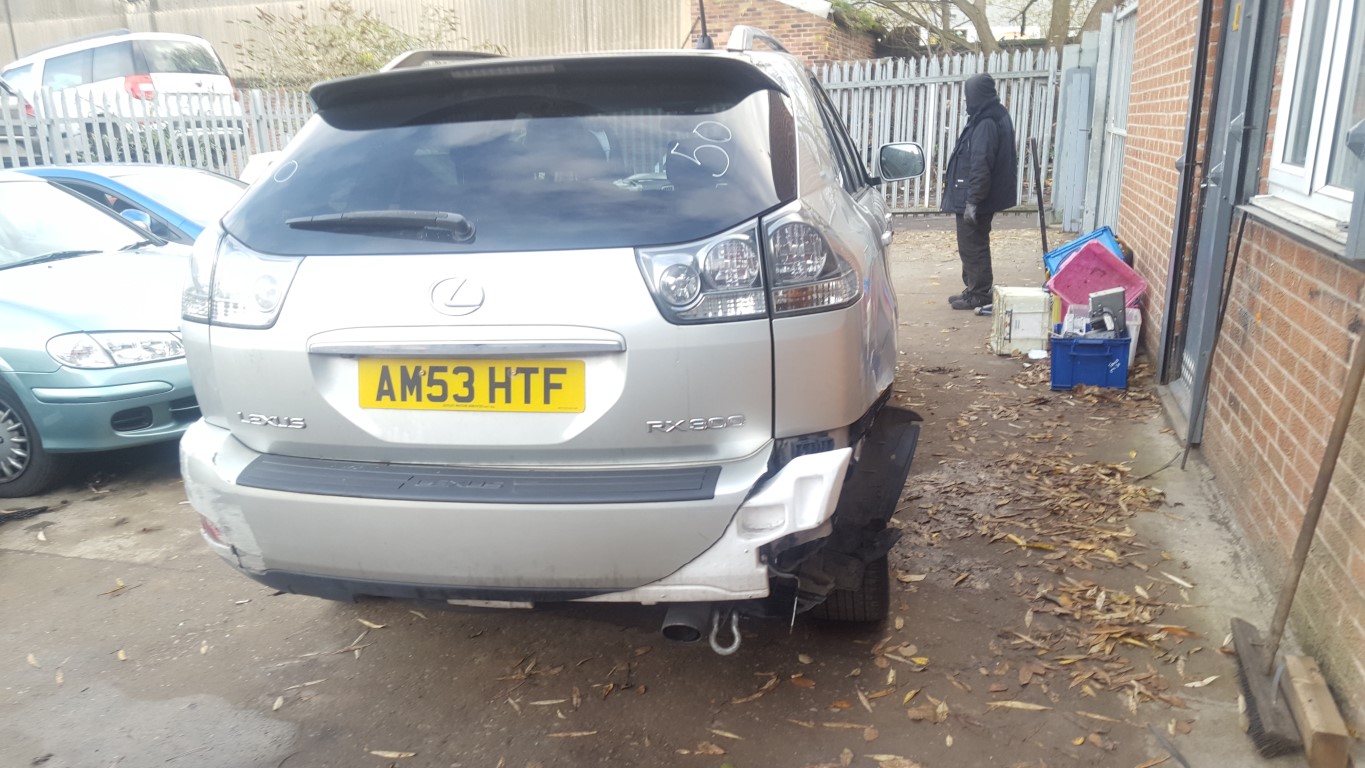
(1201, 221), (1365, 724)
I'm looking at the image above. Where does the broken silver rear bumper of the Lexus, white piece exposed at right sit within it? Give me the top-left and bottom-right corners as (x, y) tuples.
(180, 422), (850, 603)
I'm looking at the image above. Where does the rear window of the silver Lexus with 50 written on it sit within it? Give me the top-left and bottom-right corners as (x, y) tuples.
(224, 78), (796, 255)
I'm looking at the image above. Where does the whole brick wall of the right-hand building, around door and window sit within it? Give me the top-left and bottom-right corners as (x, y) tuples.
(1118, 0), (1365, 726)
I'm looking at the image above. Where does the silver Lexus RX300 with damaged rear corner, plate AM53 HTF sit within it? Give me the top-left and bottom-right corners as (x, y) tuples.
(182, 27), (923, 649)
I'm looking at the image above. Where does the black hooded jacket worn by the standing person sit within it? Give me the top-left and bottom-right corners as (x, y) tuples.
(943, 74), (1018, 214)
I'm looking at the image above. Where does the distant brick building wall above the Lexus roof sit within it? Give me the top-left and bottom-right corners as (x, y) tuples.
(706, 0), (876, 65)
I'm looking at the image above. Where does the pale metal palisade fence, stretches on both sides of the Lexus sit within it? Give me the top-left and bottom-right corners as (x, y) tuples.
(0, 50), (1059, 213)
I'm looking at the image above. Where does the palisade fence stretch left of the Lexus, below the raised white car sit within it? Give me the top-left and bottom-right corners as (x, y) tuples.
(0, 90), (313, 176)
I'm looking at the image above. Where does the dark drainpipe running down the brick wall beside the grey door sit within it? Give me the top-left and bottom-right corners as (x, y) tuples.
(1156, 0), (1222, 383)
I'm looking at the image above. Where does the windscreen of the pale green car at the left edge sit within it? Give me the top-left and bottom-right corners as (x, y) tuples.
(0, 181), (146, 269)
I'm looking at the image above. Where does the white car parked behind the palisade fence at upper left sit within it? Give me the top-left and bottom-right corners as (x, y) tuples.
(0, 30), (244, 160)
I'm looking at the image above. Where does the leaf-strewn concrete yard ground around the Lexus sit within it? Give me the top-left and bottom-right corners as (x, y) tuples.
(0, 220), (1302, 768)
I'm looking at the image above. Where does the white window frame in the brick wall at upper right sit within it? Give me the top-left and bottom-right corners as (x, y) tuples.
(1267, 0), (1365, 221)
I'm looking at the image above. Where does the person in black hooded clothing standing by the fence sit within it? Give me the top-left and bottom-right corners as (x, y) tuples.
(943, 74), (1018, 310)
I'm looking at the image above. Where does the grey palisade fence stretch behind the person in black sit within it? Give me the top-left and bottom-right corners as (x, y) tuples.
(816, 50), (1059, 213)
